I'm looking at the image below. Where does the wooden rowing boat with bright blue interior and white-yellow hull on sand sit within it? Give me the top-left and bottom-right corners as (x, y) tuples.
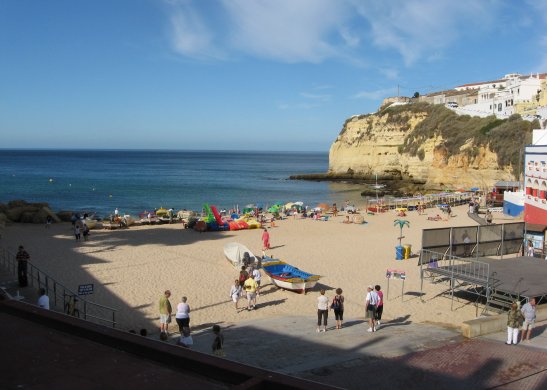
(262, 257), (321, 294)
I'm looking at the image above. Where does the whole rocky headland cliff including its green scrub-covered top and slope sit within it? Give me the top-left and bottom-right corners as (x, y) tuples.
(328, 103), (532, 189)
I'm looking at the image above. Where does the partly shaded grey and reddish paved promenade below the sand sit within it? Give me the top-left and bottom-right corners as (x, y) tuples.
(187, 315), (547, 390)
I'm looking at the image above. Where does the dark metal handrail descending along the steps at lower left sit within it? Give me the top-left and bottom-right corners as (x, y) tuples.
(0, 247), (117, 328)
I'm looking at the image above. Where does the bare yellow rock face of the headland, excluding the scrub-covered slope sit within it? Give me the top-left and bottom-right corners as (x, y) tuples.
(329, 107), (516, 189)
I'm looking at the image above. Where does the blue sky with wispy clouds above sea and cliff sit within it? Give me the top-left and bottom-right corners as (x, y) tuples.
(0, 0), (547, 151)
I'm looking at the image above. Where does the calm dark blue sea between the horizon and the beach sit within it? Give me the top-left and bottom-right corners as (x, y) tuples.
(0, 150), (366, 216)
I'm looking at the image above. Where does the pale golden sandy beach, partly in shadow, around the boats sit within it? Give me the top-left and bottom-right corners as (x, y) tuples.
(3, 206), (524, 332)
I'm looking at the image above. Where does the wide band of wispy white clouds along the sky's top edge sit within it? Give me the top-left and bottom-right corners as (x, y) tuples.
(165, 0), (510, 66)
